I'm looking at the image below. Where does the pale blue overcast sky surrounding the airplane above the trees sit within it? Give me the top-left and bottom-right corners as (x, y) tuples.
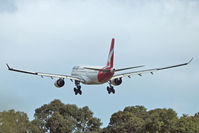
(0, 0), (199, 126)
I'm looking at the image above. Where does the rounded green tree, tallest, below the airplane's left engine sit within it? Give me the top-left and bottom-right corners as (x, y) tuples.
(34, 100), (101, 133)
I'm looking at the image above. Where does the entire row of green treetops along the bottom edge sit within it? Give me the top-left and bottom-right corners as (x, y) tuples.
(0, 100), (199, 133)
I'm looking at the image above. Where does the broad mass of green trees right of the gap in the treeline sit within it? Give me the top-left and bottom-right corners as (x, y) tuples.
(102, 106), (199, 133)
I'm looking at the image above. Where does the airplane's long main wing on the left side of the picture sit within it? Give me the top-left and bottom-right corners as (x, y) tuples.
(6, 64), (84, 82)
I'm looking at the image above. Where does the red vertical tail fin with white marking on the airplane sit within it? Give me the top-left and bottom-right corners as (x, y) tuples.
(106, 38), (115, 68)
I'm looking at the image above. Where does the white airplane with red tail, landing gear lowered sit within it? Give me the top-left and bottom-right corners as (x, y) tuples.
(6, 38), (193, 95)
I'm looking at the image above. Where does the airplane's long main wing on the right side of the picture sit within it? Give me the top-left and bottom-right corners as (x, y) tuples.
(111, 58), (193, 80)
